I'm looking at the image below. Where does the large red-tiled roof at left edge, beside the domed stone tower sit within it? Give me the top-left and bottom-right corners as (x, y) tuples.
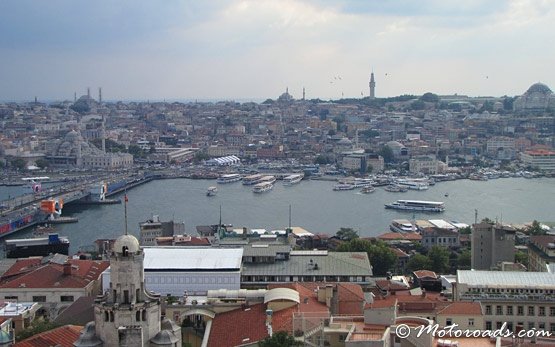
(0, 259), (110, 288)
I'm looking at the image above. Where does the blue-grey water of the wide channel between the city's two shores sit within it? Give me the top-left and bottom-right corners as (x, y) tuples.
(0, 178), (555, 252)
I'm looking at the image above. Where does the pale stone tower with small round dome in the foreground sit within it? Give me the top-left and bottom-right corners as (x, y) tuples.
(74, 234), (181, 347)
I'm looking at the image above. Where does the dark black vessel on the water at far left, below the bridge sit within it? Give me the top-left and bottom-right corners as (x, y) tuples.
(6, 234), (69, 258)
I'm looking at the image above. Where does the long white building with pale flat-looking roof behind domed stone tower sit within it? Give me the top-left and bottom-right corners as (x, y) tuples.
(102, 247), (243, 296)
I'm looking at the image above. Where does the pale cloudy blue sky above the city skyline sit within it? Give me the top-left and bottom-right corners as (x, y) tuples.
(0, 0), (555, 101)
